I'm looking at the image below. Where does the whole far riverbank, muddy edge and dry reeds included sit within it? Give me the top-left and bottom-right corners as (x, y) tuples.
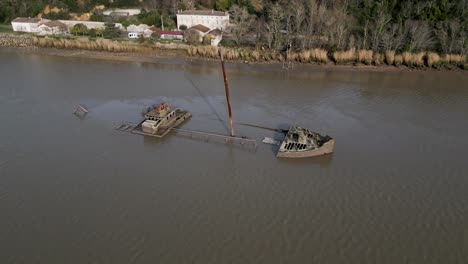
(0, 33), (468, 71)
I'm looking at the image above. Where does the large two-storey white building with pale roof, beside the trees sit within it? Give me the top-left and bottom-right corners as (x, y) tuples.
(177, 10), (229, 30)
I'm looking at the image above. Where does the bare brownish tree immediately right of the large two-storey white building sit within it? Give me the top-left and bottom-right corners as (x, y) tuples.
(230, 5), (254, 46)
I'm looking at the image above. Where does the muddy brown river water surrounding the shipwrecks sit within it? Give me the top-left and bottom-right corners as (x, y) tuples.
(0, 49), (468, 264)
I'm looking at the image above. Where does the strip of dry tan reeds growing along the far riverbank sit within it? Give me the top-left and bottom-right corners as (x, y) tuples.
(33, 37), (467, 68)
